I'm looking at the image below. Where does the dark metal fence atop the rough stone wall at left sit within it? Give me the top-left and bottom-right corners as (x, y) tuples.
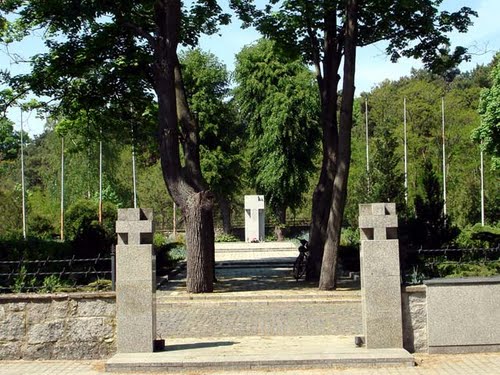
(0, 247), (116, 293)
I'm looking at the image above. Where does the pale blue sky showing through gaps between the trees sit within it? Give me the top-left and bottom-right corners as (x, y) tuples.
(0, 0), (500, 135)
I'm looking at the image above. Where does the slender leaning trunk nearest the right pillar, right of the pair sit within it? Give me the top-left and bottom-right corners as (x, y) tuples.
(319, 0), (357, 290)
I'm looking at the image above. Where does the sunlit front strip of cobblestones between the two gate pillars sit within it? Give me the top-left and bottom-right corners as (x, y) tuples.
(157, 299), (362, 338)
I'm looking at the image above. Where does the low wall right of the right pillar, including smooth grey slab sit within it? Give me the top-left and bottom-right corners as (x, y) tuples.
(402, 277), (500, 354)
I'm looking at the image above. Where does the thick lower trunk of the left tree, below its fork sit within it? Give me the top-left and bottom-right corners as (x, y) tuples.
(185, 191), (214, 293)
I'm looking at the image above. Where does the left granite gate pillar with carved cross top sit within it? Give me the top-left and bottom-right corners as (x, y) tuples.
(116, 208), (156, 353)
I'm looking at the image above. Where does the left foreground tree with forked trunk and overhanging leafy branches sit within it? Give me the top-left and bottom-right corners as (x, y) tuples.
(0, 0), (229, 293)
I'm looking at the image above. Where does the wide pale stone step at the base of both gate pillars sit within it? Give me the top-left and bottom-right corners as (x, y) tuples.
(105, 336), (415, 373)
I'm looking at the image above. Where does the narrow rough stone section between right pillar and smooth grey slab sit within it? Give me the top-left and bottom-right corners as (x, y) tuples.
(401, 285), (429, 353)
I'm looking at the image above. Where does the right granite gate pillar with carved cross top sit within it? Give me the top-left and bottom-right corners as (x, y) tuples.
(359, 203), (403, 349)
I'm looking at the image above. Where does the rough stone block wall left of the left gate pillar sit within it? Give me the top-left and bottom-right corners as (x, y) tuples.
(0, 293), (116, 360)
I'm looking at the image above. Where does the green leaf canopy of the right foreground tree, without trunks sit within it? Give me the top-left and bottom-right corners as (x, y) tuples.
(231, 0), (477, 73)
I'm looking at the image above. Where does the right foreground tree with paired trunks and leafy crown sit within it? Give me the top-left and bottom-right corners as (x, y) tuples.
(231, 0), (475, 289)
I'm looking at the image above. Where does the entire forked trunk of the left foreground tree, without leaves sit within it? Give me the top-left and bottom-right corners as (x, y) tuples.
(152, 0), (215, 293)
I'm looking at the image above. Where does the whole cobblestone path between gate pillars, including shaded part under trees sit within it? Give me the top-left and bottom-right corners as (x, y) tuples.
(157, 260), (362, 338)
